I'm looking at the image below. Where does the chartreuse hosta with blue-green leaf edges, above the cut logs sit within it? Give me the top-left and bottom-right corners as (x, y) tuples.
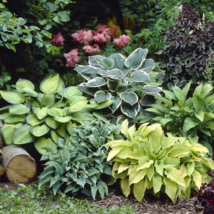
(0, 74), (104, 153)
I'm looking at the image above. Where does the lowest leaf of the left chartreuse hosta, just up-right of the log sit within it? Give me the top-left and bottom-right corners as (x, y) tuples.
(34, 137), (57, 155)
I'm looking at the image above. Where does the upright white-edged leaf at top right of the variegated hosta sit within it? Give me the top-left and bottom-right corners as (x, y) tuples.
(124, 48), (148, 71)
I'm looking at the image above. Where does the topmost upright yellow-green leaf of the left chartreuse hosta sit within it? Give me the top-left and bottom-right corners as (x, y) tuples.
(40, 74), (60, 94)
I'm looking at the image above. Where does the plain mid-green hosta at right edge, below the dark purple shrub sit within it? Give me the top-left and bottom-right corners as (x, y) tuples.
(138, 83), (214, 155)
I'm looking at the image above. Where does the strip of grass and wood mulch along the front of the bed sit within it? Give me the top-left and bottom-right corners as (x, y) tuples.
(0, 183), (203, 214)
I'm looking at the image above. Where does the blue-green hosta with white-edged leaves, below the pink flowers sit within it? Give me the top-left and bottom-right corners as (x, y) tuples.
(74, 48), (161, 118)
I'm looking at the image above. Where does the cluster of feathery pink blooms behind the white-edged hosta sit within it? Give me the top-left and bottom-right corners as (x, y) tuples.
(55, 24), (130, 67)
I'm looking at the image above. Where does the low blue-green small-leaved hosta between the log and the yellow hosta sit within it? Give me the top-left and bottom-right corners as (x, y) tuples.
(39, 120), (120, 199)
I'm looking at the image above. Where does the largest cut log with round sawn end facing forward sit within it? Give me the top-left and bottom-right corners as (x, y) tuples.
(2, 145), (36, 183)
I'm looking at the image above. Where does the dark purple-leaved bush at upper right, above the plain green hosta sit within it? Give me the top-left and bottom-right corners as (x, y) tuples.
(158, 8), (214, 88)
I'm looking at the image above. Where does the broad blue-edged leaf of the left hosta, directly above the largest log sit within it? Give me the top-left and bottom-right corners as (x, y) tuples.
(13, 125), (35, 145)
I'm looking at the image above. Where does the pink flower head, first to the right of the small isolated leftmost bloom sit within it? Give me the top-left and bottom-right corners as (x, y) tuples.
(71, 29), (93, 45)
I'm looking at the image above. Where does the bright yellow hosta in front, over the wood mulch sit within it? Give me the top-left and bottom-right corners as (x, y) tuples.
(106, 120), (214, 202)
